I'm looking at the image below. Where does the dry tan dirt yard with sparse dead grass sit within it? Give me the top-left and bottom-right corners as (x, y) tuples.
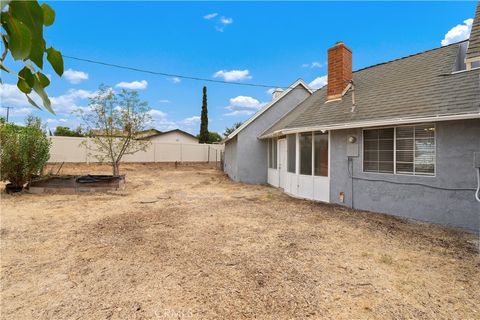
(0, 164), (480, 319)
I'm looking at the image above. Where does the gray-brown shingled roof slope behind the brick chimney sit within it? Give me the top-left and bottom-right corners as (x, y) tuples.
(261, 43), (480, 138)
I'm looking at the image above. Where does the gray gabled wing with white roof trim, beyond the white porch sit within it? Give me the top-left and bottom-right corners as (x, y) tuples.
(224, 80), (312, 183)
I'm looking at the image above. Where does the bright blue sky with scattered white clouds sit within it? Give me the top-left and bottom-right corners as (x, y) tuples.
(0, 1), (476, 134)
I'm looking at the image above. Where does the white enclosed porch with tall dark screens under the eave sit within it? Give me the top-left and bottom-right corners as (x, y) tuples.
(267, 131), (330, 202)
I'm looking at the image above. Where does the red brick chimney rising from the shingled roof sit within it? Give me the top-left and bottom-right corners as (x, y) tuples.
(327, 41), (352, 100)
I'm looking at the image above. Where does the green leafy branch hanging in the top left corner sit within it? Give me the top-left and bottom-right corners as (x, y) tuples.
(0, 0), (63, 113)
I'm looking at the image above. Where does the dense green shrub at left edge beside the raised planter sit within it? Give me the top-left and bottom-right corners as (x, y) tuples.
(0, 119), (51, 188)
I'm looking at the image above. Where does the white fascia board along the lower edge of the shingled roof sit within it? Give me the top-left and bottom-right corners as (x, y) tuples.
(259, 112), (480, 139)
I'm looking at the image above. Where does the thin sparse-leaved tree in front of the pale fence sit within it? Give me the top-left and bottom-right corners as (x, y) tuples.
(78, 86), (152, 176)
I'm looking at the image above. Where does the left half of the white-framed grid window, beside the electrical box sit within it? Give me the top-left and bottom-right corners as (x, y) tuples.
(363, 128), (394, 173)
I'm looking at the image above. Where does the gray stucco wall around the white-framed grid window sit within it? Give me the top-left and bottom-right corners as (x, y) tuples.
(330, 119), (480, 232)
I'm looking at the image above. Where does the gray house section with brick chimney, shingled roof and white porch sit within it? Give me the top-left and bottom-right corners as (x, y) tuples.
(225, 3), (480, 232)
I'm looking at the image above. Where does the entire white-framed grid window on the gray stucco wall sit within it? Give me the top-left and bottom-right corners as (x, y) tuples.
(363, 124), (436, 176)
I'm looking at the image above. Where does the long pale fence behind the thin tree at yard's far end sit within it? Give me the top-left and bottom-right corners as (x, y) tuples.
(48, 137), (224, 163)
